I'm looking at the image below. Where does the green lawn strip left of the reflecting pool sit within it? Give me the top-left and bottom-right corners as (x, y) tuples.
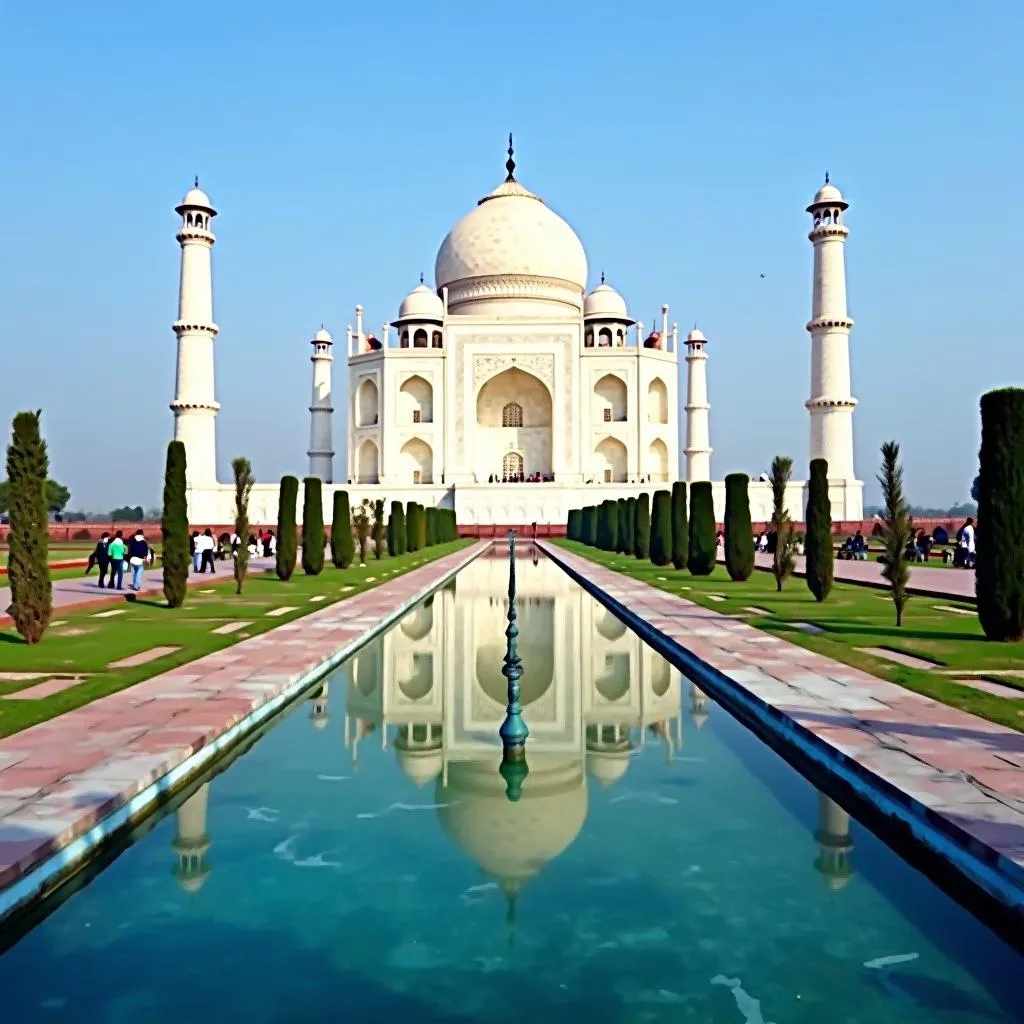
(0, 541), (471, 736)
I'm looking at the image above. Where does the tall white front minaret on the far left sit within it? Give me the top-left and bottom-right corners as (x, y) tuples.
(171, 178), (220, 487)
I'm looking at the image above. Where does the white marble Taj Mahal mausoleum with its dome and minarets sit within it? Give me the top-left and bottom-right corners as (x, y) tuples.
(171, 137), (863, 525)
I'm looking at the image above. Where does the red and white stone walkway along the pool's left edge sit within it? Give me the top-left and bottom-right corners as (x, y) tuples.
(0, 542), (489, 913)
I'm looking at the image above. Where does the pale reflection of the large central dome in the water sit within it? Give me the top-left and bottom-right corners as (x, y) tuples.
(435, 755), (587, 888)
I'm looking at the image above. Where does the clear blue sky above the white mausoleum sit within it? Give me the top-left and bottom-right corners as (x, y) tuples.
(0, 0), (1024, 509)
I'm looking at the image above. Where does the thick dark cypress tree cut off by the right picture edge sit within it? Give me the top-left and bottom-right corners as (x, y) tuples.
(975, 388), (1024, 640)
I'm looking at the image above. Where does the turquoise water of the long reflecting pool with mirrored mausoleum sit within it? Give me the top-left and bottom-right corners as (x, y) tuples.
(0, 558), (1024, 1024)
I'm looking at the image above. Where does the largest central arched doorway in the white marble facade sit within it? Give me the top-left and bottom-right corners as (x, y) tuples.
(472, 367), (552, 482)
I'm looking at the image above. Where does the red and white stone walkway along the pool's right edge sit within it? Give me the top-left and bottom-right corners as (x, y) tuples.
(538, 541), (1024, 891)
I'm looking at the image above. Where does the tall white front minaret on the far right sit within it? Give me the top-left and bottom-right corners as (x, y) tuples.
(807, 173), (857, 480)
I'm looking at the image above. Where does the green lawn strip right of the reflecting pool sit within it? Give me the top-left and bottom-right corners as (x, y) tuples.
(555, 541), (1024, 731)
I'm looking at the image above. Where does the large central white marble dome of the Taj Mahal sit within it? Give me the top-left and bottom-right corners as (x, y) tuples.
(434, 159), (587, 313)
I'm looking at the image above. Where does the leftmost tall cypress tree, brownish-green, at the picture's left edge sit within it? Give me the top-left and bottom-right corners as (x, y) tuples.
(7, 412), (51, 644)
